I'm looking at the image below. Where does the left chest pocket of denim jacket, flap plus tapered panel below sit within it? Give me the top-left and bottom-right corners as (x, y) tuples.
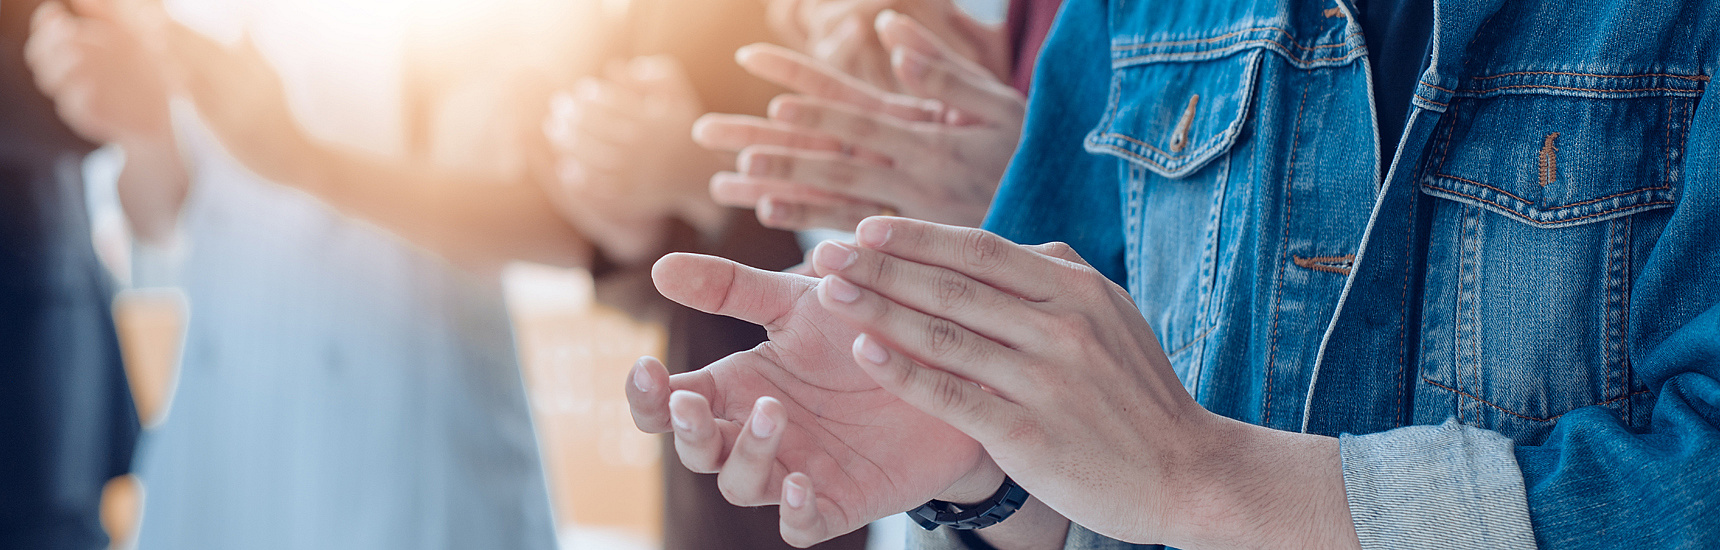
(1084, 45), (1264, 392)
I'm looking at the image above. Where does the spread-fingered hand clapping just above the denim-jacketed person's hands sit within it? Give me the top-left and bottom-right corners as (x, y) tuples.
(695, 12), (1025, 230)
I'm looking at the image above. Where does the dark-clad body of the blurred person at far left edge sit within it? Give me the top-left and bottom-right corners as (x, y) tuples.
(0, 0), (138, 550)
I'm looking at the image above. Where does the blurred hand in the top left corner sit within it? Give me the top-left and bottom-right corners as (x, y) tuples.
(24, 0), (174, 147)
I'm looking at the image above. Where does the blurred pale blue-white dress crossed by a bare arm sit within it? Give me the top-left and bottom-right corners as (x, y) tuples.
(138, 0), (556, 550)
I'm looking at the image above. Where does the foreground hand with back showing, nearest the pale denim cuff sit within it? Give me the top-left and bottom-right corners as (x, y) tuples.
(814, 218), (1355, 548)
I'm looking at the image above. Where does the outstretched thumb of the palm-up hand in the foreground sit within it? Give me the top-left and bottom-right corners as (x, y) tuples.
(650, 253), (812, 327)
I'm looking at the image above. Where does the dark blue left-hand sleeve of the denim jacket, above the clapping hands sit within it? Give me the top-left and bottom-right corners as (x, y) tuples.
(986, 0), (1127, 284)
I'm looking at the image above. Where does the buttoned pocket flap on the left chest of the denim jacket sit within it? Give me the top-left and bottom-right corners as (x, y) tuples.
(1085, 48), (1264, 177)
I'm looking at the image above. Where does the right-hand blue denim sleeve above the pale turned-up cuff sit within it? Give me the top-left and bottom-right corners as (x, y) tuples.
(1517, 83), (1720, 548)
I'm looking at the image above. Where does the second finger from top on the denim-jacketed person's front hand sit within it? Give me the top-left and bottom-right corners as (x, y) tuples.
(812, 241), (1044, 347)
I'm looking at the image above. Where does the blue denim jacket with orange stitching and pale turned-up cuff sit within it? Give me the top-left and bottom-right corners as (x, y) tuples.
(908, 0), (1720, 548)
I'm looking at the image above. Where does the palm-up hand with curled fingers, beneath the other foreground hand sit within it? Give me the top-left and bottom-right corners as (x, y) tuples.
(626, 254), (1003, 547)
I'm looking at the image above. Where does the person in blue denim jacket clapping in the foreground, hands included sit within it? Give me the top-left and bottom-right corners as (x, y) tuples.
(628, 0), (1720, 548)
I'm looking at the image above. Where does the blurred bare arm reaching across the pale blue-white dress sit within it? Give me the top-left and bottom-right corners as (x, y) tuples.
(150, 7), (590, 266)
